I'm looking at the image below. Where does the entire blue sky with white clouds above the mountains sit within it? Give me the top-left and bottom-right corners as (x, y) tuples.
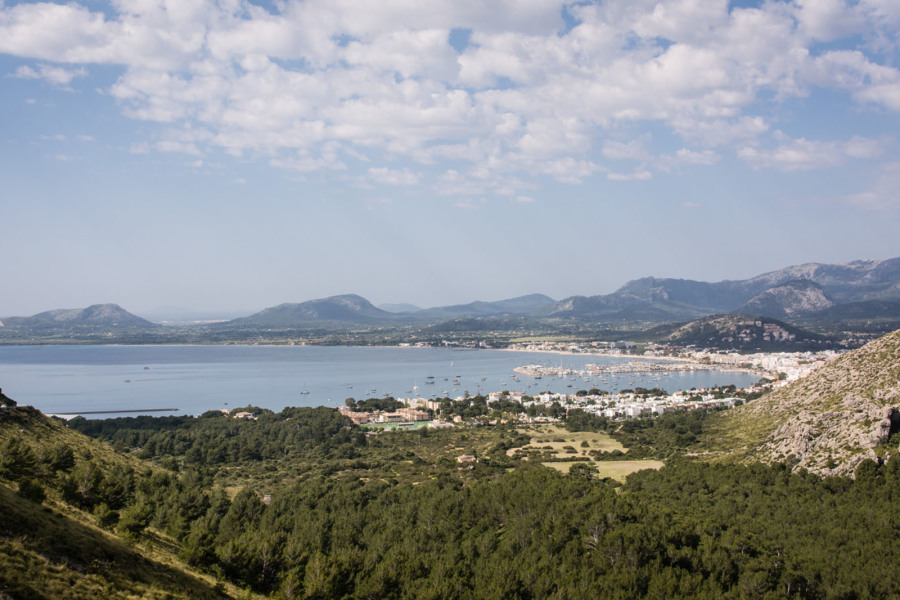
(0, 0), (900, 318)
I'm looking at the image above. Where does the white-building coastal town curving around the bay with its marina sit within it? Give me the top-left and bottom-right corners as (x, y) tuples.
(339, 342), (839, 429)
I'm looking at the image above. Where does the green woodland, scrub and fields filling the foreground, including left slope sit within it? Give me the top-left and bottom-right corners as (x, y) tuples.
(0, 386), (900, 600)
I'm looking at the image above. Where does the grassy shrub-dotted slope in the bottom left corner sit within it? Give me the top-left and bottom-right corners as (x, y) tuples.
(0, 408), (258, 600)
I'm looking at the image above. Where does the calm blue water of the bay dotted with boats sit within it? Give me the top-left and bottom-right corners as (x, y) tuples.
(0, 346), (758, 418)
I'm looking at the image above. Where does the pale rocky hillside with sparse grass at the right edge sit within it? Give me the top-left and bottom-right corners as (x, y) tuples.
(706, 330), (900, 475)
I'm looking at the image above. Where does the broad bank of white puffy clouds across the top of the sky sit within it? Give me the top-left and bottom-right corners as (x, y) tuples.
(0, 0), (900, 197)
